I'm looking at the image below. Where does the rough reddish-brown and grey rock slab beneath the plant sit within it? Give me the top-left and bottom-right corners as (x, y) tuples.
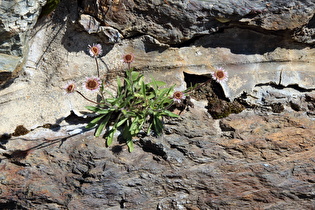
(0, 107), (315, 209)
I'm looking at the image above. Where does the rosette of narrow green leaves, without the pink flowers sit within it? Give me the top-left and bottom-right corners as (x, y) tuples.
(86, 69), (178, 152)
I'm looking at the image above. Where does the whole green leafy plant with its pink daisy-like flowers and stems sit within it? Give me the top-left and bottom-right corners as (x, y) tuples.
(65, 44), (184, 152)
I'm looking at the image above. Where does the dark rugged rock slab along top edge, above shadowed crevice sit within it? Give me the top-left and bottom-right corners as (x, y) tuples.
(80, 0), (315, 44)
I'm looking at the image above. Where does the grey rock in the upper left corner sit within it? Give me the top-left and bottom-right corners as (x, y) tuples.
(0, 0), (46, 85)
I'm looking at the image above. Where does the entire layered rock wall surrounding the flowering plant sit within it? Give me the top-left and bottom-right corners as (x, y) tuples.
(0, 0), (315, 209)
